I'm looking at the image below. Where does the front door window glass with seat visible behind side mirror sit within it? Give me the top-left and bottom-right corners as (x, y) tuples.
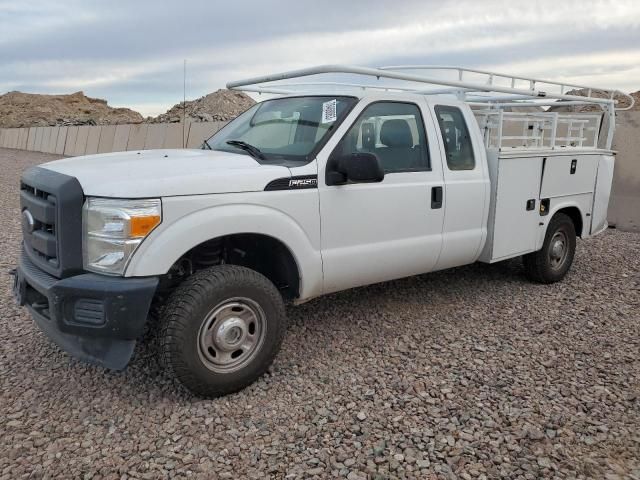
(334, 102), (429, 173)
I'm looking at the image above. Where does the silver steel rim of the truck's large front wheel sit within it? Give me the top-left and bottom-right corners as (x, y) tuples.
(198, 297), (266, 373)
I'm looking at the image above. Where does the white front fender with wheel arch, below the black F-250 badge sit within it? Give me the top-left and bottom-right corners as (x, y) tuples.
(125, 189), (322, 298)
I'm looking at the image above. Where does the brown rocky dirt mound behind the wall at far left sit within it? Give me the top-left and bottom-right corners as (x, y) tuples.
(0, 92), (143, 128)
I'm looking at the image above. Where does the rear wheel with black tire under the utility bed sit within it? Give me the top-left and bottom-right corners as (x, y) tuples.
(522, 213), (576, 283)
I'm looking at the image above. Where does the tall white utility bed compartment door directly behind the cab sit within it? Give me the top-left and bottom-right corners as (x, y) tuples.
(491, 157), (542, 262)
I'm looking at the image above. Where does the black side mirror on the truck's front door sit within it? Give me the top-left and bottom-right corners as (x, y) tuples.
(327, 152), (384, 185)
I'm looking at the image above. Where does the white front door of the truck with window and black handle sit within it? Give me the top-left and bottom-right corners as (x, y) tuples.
(318, 101), (446, 293)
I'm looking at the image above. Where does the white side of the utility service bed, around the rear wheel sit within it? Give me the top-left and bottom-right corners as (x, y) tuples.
(479, 149), (614, 263)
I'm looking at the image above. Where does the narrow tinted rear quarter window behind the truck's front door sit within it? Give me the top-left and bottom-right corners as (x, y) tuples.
(435, 105), (476, 170)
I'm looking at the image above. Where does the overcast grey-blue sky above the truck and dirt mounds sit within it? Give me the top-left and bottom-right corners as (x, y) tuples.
(0, 0), (640, 115)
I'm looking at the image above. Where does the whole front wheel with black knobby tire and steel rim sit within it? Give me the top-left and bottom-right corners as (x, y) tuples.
(160, 265), (286, 397)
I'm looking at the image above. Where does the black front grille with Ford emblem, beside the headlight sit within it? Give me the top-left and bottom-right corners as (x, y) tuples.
(20, 167), (84, 278)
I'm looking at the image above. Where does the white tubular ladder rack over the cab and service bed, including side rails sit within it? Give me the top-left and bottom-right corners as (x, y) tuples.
(227, 65), (634, 150)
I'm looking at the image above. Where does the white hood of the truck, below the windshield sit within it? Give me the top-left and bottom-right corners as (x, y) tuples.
(41, 150), (291, 198)
